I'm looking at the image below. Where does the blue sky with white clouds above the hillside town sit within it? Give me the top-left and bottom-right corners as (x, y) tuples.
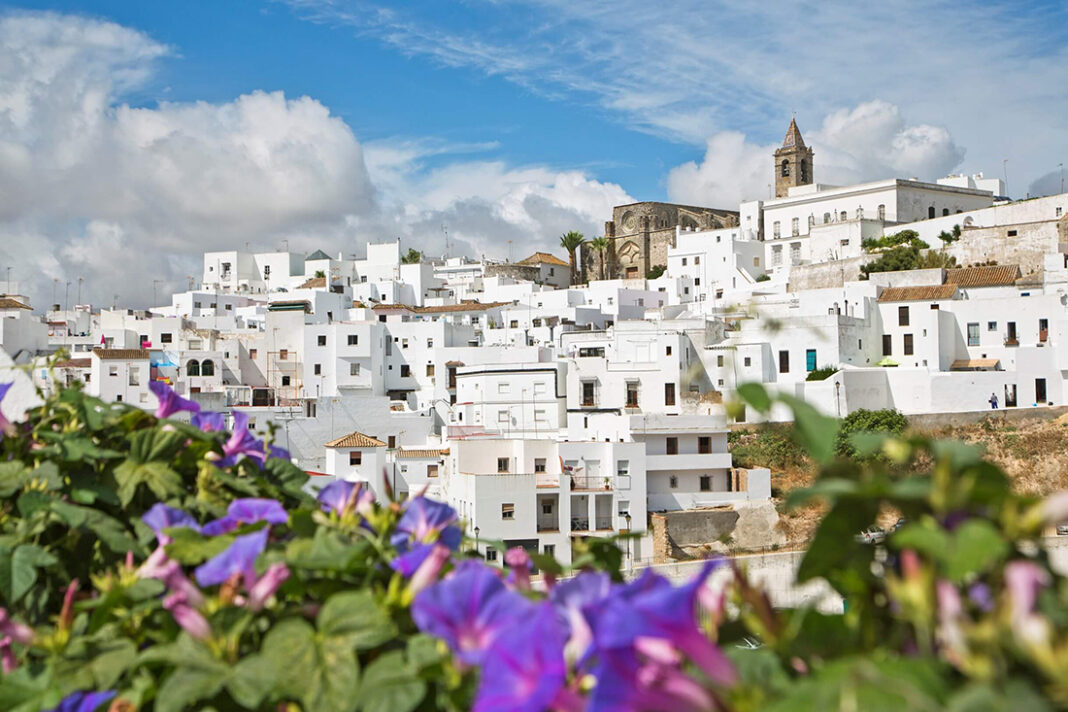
(0, 0), (1068, 302)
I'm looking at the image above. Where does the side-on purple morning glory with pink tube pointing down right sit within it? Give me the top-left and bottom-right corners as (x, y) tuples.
(593, 559), (737, 684)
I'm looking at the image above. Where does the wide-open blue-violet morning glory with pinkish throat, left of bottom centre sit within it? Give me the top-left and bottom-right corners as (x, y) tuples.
(411, 560), (534, 665)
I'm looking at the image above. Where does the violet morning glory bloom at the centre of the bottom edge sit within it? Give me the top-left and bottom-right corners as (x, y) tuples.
(472, 602), (567, 712)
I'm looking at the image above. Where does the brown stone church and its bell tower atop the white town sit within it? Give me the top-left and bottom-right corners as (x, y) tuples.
(580, 120), (813, 282)
